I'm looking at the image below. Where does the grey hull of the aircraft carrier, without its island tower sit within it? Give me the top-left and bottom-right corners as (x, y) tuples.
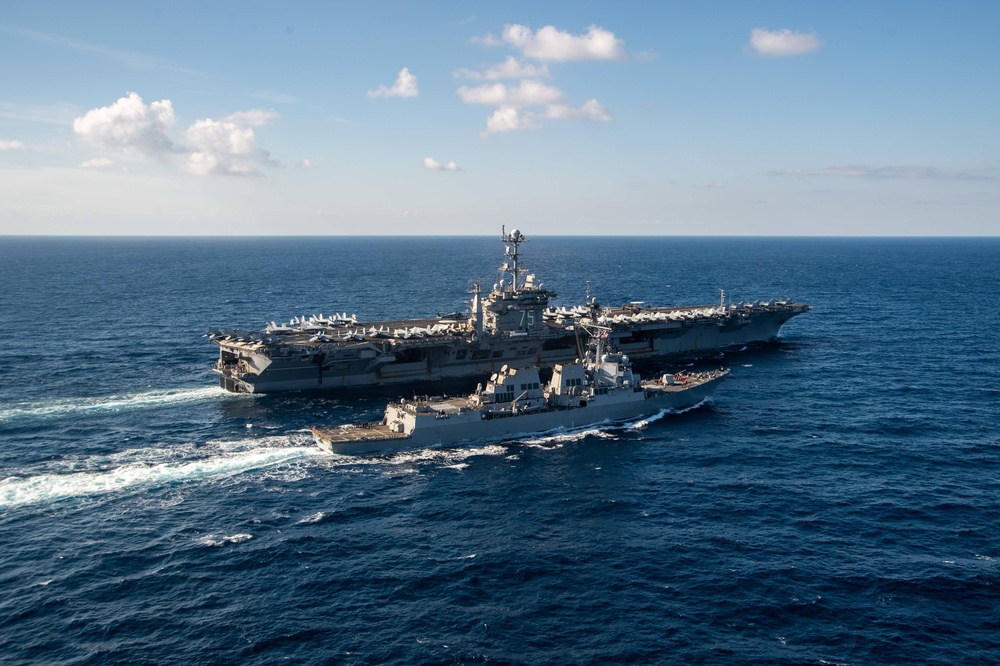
(215, 304), (809, 393)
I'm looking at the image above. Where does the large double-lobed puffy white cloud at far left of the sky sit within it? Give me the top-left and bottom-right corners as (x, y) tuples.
(73, 93), (277, 175)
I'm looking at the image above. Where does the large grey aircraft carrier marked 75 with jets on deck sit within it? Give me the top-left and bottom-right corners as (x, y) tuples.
(209, 229), (811, 393)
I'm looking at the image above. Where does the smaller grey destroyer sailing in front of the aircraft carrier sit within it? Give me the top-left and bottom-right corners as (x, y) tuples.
(313, 329), (729, 454)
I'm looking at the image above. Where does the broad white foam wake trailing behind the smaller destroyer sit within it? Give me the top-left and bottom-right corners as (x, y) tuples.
(0, 447), (320, 511)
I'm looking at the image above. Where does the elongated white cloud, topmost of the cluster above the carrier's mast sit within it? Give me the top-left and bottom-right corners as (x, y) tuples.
(496, 24), (625, 62)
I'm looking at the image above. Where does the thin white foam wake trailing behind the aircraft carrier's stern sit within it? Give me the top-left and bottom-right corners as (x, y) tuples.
(0, 386), (238, 423)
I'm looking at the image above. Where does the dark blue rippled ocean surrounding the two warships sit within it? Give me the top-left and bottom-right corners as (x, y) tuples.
(0, 236), (1000, 665)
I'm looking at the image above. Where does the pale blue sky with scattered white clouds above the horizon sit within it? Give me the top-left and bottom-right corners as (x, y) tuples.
(0, 0), (1000, 235)
